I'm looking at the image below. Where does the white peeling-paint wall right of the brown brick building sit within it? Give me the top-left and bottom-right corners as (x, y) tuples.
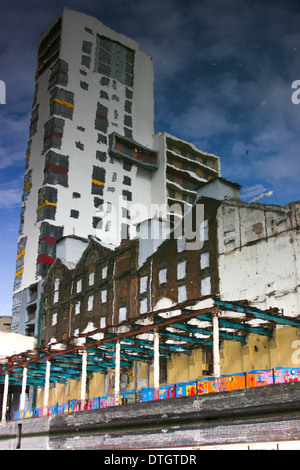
(217, 202), (300, 316)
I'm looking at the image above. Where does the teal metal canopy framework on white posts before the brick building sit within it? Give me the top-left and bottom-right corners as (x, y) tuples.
(0, 297), (300, 387)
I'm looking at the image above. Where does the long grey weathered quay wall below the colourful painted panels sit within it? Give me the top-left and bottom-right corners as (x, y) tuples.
(0, 382), (300, 451)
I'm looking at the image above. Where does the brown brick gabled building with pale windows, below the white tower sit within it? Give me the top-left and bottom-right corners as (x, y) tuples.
(41, 192), (220, 343)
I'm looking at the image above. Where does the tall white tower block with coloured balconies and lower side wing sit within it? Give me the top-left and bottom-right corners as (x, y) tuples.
(12, 8), (220, 336)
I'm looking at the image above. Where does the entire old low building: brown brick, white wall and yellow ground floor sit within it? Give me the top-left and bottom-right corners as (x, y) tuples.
(37, 178), (300, 402)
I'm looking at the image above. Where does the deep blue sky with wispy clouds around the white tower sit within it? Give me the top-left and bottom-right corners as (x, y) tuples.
(0, 0), (300, 315)
